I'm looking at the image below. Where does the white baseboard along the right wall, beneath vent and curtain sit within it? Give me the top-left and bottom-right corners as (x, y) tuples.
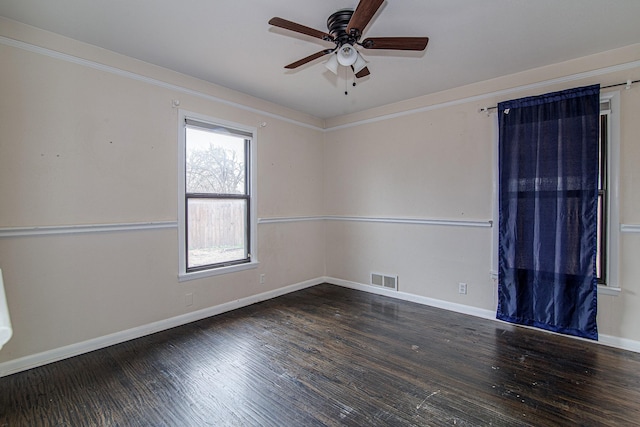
(322, 277), (640, 353)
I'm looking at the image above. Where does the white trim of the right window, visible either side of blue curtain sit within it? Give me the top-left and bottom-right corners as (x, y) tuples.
(490, 91), (621, 301)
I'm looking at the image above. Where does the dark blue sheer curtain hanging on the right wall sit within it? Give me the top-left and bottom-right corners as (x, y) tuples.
(497, 85), (600, 340)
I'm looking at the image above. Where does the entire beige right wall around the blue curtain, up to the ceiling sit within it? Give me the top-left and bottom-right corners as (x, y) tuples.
(325, 45), (640, 344)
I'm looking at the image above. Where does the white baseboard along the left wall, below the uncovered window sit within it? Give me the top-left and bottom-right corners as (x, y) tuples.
(0, 277), (324, 377)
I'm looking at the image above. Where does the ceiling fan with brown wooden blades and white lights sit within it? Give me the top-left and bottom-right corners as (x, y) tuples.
(269, 0), (429, 78)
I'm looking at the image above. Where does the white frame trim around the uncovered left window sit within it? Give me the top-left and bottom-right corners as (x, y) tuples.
(178, 109), (259, 282)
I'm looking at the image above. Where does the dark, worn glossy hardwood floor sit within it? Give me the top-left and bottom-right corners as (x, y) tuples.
(0, 285), (640, 426)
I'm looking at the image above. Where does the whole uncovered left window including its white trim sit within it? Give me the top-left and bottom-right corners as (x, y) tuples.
(178, 111), (256, 279)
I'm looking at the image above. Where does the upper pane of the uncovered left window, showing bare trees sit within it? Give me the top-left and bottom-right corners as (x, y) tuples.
(186, 127), (246, 194)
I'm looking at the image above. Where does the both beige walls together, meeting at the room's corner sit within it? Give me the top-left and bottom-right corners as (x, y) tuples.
(0, 18), (640, 372)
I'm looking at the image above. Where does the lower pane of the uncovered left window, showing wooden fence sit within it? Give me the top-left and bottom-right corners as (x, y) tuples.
(187, 198), (249, 268)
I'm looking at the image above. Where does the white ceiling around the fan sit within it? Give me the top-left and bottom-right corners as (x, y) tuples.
(0, 0), (640, 118)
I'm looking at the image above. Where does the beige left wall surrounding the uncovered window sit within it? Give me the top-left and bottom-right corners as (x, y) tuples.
(0, 20), (324, 362)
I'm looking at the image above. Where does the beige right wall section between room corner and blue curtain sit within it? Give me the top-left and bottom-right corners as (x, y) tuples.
(325, 107), (494, 308)
